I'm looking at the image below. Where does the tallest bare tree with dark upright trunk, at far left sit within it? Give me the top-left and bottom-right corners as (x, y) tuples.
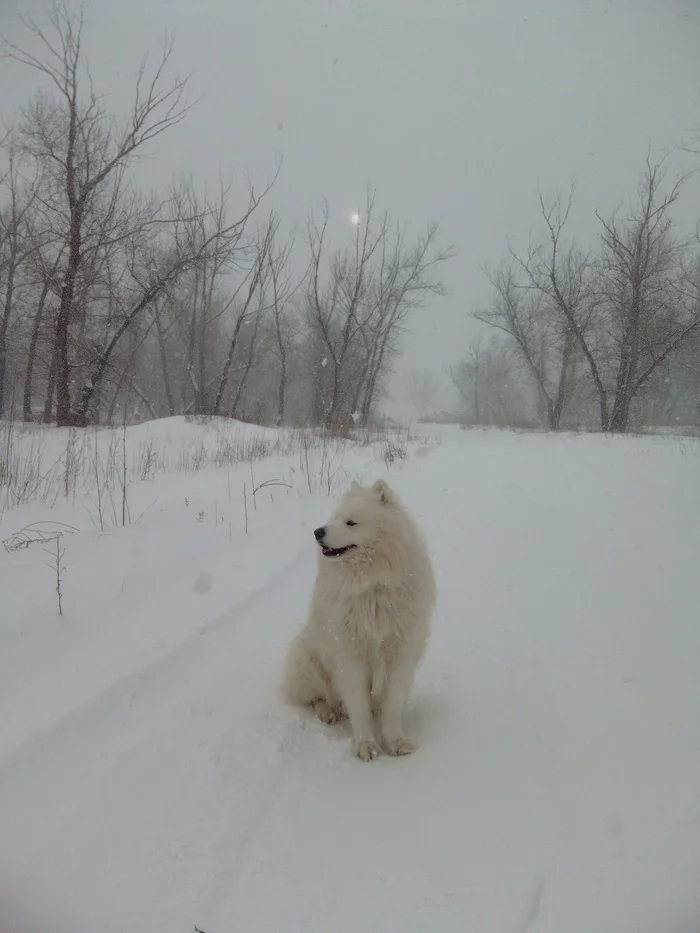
(4, 2), (194, 424)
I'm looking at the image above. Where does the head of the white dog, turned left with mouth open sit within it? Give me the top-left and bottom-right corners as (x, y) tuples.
(314, 479), (397, 561)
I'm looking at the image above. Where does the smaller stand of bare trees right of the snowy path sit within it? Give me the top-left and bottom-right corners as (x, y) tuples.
(450, 158), (700, 432)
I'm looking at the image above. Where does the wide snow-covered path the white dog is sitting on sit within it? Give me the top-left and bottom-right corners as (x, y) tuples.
(0, 434), (700, 933)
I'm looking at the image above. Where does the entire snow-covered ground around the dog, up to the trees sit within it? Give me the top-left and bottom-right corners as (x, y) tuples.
(0, 419), (700, 933)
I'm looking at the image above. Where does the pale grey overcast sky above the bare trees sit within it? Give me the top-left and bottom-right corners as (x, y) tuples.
(0, 0), (700, 416)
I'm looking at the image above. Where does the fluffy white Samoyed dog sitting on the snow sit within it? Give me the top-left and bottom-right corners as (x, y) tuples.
(284, 480), (436, 761)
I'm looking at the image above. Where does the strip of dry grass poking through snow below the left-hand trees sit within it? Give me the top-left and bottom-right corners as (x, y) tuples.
(0, 419), (416, 516)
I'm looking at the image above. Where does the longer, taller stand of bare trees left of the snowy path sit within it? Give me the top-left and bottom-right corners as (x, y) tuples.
(0, 3), (452, 429)
